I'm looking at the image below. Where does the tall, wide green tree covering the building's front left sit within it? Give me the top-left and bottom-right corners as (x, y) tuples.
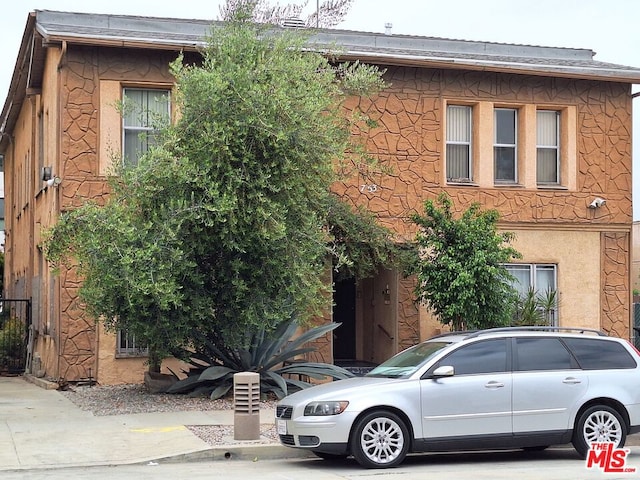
(45, 2), (393, 369)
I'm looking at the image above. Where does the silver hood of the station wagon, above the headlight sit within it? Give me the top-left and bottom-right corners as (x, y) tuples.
(278, 377), (406, 405)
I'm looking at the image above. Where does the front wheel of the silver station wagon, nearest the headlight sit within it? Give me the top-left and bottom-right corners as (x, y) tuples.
(351, 411), (409, 468)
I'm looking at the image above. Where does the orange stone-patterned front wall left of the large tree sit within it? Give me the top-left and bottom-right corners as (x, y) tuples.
(58, 47), (176, 381)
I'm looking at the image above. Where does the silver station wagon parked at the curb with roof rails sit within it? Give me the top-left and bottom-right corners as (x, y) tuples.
(276, 327), (640, 468)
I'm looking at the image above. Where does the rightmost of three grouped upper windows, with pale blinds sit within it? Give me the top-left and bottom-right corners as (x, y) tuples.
(536, 110), (560, 185)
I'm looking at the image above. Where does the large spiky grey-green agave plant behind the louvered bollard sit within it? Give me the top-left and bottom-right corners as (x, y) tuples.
(167, 319), (354, 400)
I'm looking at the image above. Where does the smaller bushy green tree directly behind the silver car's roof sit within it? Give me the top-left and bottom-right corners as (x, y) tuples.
(412, 193), (520, 330)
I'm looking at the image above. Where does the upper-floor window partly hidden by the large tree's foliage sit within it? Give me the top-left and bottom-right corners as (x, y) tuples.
(122, 88), (169, 165)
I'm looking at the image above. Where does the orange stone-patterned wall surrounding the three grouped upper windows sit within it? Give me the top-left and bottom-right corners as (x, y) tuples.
(335, 67), (632, 343)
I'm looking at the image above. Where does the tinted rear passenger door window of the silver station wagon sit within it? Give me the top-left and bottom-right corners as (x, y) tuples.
(515, 338), (578, 372)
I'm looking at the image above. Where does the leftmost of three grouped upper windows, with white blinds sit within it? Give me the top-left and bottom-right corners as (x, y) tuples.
(446, 105), (473, 182)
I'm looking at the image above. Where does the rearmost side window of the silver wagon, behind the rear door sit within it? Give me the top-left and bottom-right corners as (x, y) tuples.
(564, 338), (636, 370)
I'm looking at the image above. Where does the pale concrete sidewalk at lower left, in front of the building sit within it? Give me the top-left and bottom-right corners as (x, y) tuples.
(0, 377), (308, 470)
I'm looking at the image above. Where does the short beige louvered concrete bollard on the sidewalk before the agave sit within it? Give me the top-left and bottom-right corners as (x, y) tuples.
(233, 372), (260, 440)
